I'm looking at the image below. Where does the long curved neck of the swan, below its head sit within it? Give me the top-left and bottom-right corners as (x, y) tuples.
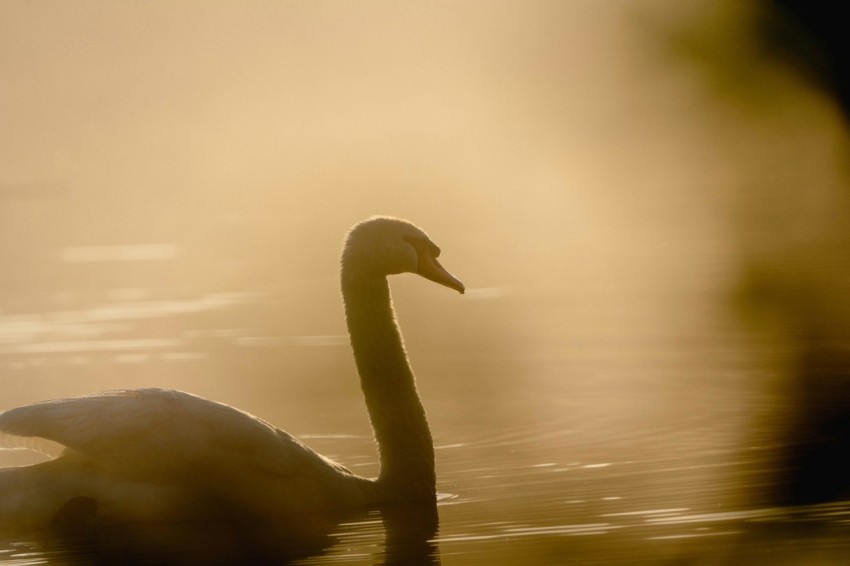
(342, 266), (435, 499)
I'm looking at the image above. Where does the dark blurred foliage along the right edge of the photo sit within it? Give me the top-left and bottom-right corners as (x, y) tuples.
(743, 0), (850, 505)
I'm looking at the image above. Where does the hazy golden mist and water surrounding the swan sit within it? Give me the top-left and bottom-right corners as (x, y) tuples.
(0, 0), (850, 565)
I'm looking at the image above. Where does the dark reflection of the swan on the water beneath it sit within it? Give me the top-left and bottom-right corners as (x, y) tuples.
(6, 501), (440, 566)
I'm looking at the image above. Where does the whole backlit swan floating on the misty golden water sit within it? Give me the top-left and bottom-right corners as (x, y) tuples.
(0, 216), (464, 530)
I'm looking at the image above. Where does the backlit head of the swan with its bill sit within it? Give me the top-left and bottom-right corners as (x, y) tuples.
(342, 216), (464, 293)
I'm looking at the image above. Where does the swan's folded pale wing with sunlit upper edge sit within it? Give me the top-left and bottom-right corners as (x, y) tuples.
(0, 389), (344, 480)
